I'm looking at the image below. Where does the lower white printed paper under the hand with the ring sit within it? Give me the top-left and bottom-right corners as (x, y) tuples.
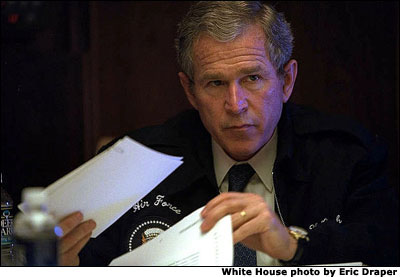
(110, 208), (233, 266)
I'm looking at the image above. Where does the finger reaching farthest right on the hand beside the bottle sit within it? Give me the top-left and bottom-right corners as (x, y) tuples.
(60, 220), (96, 253)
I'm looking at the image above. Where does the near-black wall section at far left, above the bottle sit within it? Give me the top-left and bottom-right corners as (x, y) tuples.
(1, 1), (88, 203)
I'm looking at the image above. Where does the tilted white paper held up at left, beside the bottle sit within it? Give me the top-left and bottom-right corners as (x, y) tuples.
(20, 137), (183, 238)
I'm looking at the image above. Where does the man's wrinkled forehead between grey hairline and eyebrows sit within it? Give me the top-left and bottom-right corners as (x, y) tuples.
(193, 25), (269, 71)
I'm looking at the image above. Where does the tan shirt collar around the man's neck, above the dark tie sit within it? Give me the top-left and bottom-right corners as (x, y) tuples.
(212, 129), (278, 192)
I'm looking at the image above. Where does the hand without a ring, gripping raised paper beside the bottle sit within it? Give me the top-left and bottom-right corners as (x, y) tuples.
(58, 212), (96, 266)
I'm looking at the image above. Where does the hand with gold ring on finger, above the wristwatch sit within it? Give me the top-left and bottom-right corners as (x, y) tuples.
(201, 192), (297, 261)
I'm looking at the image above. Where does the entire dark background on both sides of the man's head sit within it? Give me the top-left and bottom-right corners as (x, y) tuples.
(1, 1), (399, 203)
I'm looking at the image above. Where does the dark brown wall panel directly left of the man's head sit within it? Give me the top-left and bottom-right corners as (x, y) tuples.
(84, 1), (191, 157)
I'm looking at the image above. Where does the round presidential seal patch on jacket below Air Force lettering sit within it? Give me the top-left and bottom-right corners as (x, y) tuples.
(128, 217), (171, 251)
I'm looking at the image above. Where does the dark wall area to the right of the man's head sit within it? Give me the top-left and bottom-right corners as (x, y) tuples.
(276, 1), (399, 190)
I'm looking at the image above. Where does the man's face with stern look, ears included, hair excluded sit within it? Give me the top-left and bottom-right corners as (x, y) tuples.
(179, 25), (297, 161)
